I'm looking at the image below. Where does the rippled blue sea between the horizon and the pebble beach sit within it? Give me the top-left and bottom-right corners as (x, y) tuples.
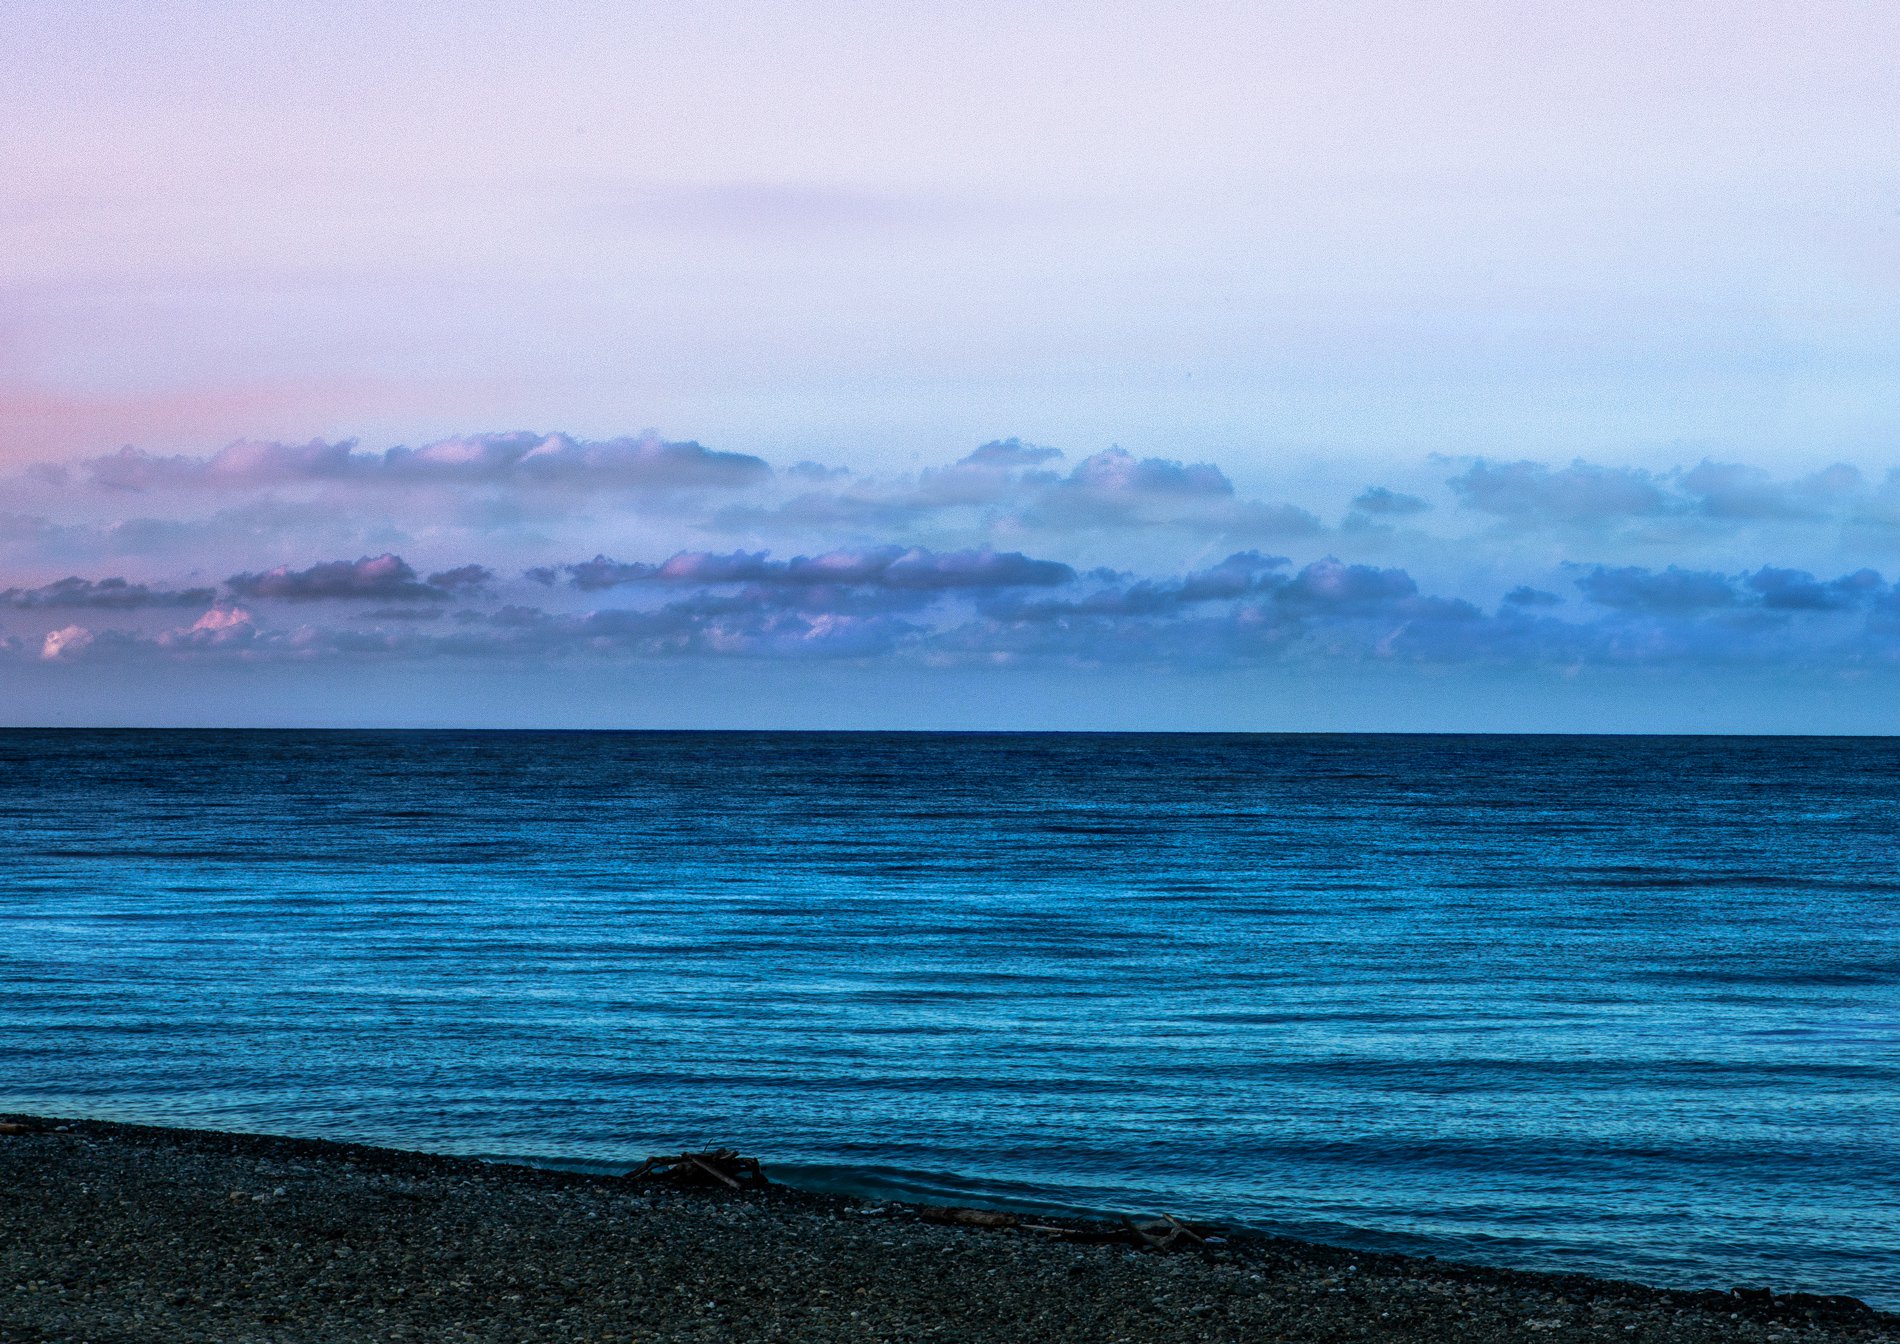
(0, 730), (1900, 1308)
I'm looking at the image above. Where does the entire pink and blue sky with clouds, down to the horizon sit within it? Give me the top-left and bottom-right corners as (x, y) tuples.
(0, 0), (1900, 732)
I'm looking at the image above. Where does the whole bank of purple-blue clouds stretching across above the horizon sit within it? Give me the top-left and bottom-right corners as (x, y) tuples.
(11, 433), (1900, 688)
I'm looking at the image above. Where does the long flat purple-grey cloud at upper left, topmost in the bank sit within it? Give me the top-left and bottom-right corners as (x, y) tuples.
(40, 432), (771, 494)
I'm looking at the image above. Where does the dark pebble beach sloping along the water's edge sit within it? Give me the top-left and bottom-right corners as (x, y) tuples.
(0, 1114), (1900, 1344)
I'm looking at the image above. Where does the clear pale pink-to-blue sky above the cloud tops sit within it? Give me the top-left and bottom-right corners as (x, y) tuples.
(11, 0), (1900, 477)
